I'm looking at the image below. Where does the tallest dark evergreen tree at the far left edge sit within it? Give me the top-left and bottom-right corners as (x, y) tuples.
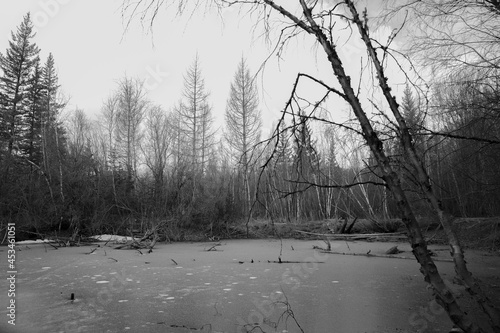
(0, 13), (39, 154)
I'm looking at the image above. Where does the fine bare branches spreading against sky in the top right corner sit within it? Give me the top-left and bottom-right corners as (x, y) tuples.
(384, 0), (500, 75)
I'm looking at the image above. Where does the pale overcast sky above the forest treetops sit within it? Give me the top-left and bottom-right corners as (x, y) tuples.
(0, 0), (408, 134)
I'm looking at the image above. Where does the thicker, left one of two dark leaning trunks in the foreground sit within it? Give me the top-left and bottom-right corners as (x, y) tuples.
(264, 0), (482, 332)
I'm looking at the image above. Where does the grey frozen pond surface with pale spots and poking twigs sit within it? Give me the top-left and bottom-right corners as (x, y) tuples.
(0, 240), (500, 333)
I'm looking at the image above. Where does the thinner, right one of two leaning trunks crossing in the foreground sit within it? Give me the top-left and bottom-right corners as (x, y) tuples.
(346, 1), (500, 332)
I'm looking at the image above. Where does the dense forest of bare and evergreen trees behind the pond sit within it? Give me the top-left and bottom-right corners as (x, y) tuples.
(0, 7), (500, 239)
